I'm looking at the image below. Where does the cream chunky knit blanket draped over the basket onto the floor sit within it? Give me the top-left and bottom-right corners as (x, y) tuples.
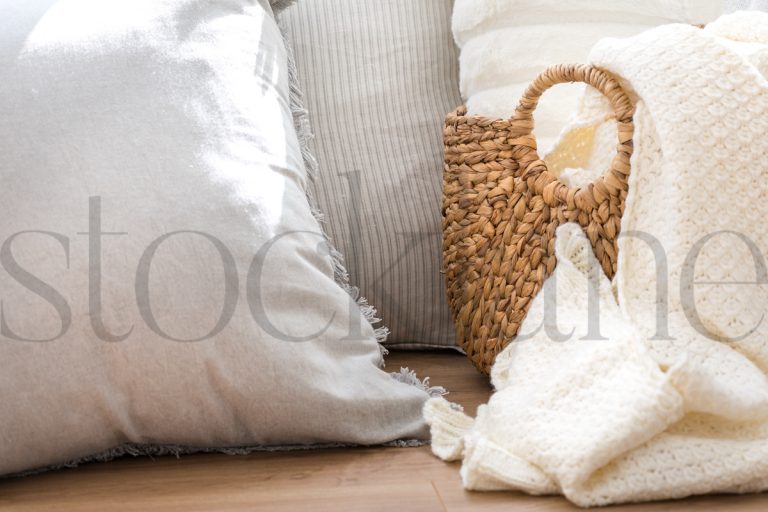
(425, 13), (768, 506)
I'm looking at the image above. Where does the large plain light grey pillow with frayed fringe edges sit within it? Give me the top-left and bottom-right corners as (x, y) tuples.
(0, 0), (427, 473)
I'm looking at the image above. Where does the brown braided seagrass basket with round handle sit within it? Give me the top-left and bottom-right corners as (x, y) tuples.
(443, 65), (634, 374)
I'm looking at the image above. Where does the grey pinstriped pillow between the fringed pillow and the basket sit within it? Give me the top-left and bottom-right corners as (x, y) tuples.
(281, 0), (461, 348)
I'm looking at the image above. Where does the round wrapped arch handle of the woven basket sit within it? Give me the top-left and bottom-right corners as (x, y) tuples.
(511, 64), (635, 204)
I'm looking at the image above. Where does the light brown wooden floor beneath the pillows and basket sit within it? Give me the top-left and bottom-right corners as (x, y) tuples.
(0, 352), (768, 512)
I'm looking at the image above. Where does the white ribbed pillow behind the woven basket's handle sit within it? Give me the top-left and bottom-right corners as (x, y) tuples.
(453, 0), (723, 153)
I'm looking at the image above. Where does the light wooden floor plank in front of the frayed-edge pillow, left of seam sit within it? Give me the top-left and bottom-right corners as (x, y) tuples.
(0, 448), (443, 512)
